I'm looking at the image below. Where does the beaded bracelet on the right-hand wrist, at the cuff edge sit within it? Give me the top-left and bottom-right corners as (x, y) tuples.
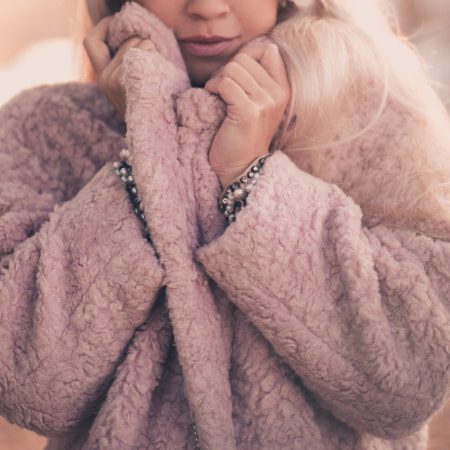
(218, 153), (271, 224)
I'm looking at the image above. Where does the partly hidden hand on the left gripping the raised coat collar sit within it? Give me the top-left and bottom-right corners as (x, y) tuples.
(83, 16), (156, 117)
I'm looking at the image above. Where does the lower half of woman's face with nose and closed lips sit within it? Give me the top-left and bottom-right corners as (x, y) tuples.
(138, 0), (279, 87)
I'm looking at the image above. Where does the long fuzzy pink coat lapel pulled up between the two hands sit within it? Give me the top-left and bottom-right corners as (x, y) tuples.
(110, 3), (235, 449)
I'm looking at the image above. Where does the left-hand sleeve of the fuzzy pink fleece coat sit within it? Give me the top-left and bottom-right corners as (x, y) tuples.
(0, 87), (163, 436)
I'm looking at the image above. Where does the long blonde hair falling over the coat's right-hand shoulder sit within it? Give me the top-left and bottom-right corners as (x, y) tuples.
(81, 0), (450, 239)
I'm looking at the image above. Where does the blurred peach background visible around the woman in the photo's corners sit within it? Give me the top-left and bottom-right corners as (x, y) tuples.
(0, 0), (450, 450)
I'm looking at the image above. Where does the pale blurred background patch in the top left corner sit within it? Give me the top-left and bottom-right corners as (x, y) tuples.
(0, 0), (80, 104)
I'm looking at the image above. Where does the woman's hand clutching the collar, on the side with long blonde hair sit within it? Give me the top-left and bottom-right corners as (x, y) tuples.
(205, 43), (291, 186)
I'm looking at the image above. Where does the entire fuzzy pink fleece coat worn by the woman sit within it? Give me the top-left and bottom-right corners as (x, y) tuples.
(0, 4), (450, 450)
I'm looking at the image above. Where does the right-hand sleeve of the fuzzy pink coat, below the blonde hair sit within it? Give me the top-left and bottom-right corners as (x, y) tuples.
(196, 151), (450, 439)
